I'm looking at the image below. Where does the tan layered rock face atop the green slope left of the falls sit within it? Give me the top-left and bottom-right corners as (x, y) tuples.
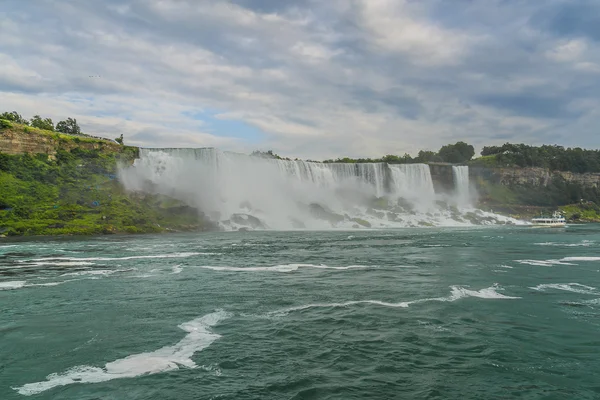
(0, 128), (120, 158)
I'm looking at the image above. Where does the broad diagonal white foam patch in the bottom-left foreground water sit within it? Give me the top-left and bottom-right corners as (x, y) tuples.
(13, 311), (230, 396)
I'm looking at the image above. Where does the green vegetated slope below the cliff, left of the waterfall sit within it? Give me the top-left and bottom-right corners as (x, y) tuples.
(0, 122), (216, 235)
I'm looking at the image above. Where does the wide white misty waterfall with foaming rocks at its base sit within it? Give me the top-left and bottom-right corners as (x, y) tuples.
(120, 148), (515, 229)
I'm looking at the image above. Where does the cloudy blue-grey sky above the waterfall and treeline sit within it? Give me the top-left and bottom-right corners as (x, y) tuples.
(0, 0), (600, 160)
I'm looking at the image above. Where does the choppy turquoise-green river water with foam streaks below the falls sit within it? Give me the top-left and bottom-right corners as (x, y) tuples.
(0, 225), (600, 400)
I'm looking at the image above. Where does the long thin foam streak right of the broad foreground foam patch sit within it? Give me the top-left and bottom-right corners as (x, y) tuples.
(267, 284), (520, 316)
